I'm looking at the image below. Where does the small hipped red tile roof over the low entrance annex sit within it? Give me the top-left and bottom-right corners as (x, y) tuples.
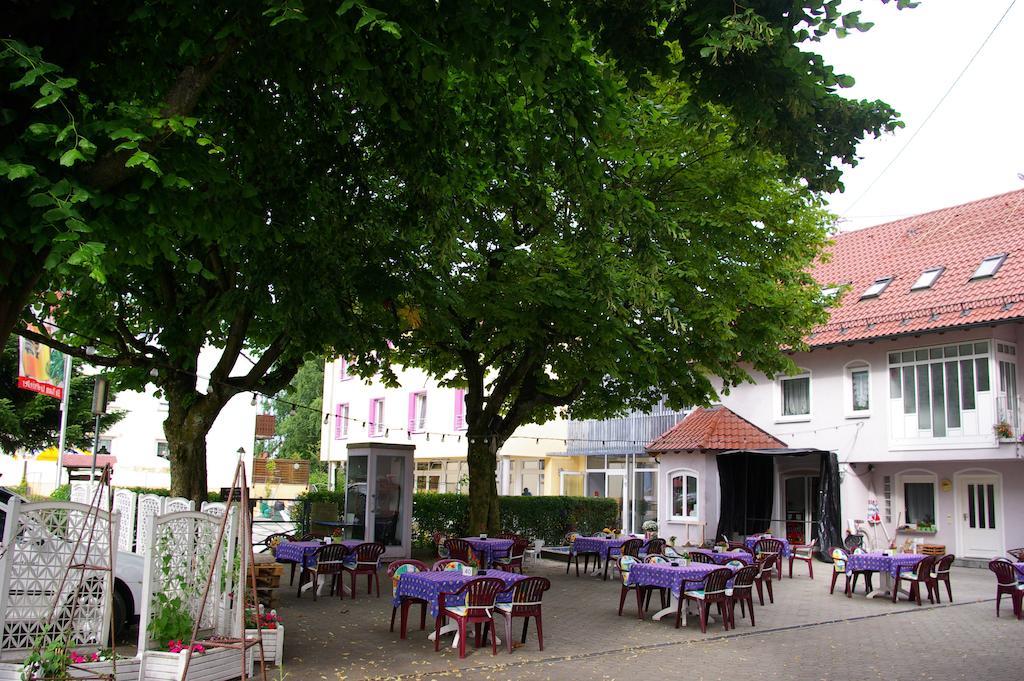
(647, 407), (787, 452)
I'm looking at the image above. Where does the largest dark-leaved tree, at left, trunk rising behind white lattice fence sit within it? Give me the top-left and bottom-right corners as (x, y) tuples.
(8, 0), (675, 499)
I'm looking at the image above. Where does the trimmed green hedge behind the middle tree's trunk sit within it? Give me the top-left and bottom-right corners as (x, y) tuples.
(413, 493), (618, 546)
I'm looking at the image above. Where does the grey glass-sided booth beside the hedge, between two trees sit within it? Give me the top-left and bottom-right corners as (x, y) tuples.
(343, 442), (416, 558)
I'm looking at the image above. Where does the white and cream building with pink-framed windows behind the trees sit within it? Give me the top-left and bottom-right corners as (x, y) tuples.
(321, 357), (574, 495)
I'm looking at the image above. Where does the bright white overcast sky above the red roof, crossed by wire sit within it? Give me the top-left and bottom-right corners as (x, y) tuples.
(819, 0), (1024, 230)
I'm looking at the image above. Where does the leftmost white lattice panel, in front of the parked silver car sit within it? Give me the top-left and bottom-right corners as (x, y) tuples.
(0, 499), (118, 653)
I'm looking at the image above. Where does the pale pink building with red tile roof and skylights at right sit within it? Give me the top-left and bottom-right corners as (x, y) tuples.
(663, 190), (1024, 559)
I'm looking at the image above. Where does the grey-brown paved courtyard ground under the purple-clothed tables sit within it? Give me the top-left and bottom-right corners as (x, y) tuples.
(273, 561), (1024, 681)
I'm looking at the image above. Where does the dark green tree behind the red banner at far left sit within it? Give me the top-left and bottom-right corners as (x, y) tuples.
(0, 337), (124, 454)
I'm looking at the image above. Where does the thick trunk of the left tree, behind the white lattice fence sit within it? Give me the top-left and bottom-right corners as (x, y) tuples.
(164, 391), (219, 499)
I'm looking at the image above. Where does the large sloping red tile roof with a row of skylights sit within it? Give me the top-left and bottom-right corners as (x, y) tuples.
(808, 190), (1024, 346)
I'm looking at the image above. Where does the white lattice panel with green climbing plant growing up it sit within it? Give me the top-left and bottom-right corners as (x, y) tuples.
(139, 511), (225, 650)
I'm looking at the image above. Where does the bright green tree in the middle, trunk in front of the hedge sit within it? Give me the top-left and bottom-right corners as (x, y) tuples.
(378, 34), (909, 531)
